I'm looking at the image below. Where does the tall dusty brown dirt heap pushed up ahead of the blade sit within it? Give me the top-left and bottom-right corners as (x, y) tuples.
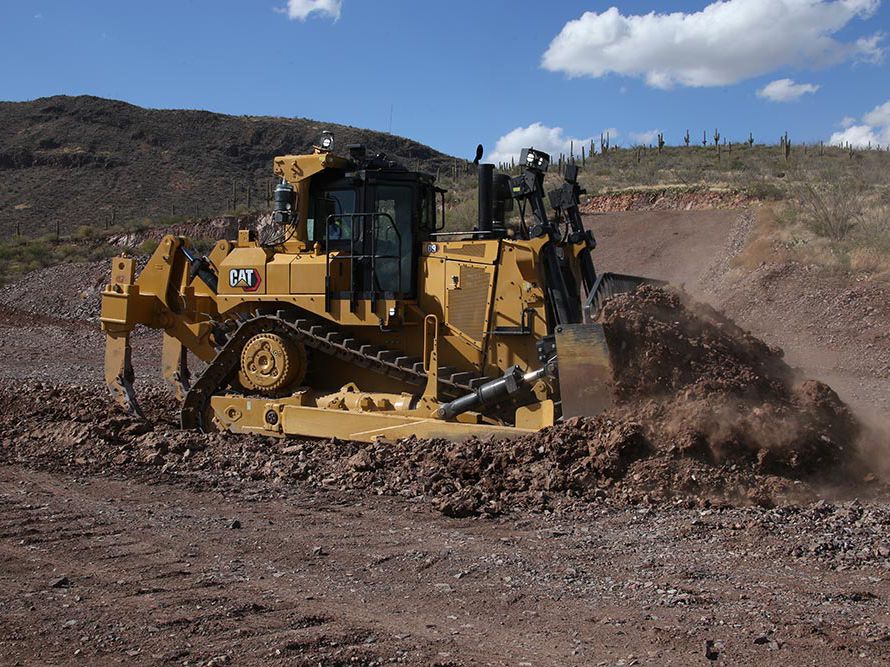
(603, 286), (859, 477)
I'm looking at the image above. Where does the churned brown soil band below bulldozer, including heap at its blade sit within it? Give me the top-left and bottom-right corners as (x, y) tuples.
(0, 287), (876, 516)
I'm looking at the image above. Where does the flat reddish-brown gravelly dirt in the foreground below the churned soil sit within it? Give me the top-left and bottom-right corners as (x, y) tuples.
(0, 466), (890, 666)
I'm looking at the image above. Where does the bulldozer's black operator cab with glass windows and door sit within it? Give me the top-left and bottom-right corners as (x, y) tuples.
(306, 156), (436, 300)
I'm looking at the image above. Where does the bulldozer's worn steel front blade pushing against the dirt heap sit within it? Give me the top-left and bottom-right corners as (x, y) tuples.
(556, 273), (664, 418)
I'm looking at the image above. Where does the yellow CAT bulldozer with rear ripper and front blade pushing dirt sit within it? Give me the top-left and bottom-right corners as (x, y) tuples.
(101, 133), (646, 441)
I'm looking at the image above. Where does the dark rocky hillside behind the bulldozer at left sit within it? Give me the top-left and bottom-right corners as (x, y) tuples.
(0, 96), (451, 236)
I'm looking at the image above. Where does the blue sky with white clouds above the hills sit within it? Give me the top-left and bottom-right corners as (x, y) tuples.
(0, 0), (890, 156)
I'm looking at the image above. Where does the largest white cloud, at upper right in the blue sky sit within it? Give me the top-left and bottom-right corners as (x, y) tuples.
(542, 0), (884, 88)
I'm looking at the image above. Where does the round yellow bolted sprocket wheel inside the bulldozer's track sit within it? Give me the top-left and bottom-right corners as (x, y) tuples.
(238, 333), (306, 396)
